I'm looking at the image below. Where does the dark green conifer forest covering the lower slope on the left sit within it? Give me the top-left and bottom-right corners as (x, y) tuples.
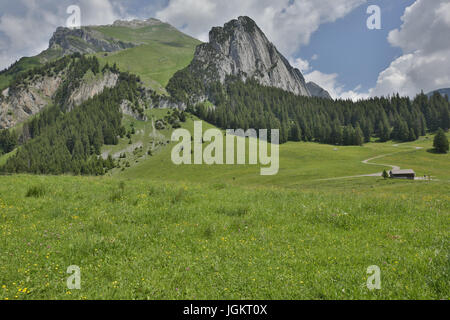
(0, 54), (139, 175)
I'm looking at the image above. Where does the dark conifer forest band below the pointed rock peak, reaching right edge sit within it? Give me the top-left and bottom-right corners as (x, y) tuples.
(167, 69), (450, 145)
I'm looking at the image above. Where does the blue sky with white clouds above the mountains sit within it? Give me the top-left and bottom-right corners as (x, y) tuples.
(0, 0), (450, 100)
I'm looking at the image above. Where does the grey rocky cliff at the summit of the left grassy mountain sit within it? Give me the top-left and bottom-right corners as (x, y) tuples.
(49, 27), (136, 55)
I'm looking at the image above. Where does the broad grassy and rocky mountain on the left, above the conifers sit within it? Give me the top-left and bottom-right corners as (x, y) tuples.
(0, 19), (201, 129)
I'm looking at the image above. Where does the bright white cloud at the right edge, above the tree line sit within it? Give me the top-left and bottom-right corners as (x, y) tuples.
(370, 0), (450, 97)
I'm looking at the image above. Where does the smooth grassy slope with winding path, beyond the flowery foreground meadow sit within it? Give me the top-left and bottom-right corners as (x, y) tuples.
(116, 113), (450, 189)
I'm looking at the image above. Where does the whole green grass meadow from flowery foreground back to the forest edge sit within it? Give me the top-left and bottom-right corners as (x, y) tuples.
(0, 115), (450, 300)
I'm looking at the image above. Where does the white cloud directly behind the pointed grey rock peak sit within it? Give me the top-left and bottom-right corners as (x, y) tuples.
(157, 0), (366, 57)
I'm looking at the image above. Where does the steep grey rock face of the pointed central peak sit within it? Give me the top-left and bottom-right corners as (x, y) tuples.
(190, 17), (310, 96)
